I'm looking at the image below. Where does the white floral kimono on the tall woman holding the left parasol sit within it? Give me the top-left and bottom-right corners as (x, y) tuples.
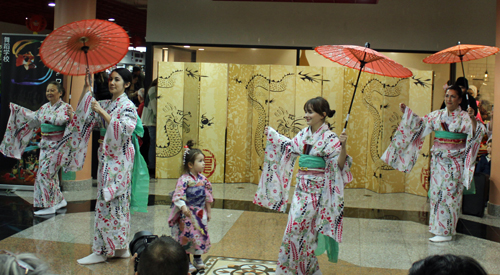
(55, 92), (138, 257)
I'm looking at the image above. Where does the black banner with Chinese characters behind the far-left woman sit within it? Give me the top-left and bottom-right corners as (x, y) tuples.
(0, 33), (63, 187)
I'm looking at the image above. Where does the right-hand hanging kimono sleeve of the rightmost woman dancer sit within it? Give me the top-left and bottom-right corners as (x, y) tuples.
(462, 118), (486, 189)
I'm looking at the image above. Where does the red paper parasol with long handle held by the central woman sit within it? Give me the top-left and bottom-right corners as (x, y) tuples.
(315, 43), (413, 131)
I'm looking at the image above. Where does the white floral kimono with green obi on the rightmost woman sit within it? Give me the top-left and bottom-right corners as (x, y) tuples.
(381, 107), (485, 236)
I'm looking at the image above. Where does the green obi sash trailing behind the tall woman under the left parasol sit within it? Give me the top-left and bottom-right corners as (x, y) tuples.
(100, 116), (149, 213)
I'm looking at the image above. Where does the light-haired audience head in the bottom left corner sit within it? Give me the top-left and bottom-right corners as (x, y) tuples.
(0, 250), (48, 275)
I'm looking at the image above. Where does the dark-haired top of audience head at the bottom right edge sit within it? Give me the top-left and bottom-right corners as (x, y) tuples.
(408, 254), (487, 275)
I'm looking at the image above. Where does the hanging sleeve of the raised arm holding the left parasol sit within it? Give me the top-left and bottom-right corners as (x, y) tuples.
(52, 92), (97, 172)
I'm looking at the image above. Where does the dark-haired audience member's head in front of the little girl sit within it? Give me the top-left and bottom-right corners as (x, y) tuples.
(136, 235), (189, 275)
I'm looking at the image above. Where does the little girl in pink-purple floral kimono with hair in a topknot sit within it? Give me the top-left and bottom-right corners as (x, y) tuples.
(168, 140), (214, 272)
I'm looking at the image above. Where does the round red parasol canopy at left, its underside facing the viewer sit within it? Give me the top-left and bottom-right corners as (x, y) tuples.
(40, 19), (129, 75)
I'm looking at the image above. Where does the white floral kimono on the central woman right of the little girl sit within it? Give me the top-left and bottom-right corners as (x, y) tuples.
(254, 124), (352, 274)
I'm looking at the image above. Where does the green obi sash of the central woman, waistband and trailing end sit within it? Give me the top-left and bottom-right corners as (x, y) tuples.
(299, 154), (339, 263)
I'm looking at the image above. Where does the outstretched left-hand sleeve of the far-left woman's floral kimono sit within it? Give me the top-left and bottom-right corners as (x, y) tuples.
(0, 103), (40, 159)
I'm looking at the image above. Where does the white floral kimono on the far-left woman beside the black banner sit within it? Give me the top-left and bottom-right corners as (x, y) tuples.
(0, 99), (70, 208)
